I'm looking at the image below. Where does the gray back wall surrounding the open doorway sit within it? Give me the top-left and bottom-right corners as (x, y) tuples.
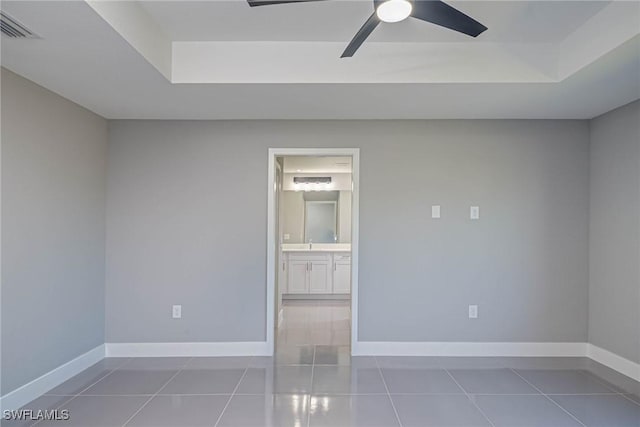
(106, 120), (589, 342)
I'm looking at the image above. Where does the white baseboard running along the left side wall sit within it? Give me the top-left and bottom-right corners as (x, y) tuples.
(0, 344), (105, 410)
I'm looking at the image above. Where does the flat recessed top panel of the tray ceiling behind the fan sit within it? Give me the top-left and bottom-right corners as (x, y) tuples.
(141, 0), (607, 45)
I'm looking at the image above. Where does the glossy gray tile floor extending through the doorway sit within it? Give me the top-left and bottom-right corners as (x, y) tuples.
(2, 303), (640, 427)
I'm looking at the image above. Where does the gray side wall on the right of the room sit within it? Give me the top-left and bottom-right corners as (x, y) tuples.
(589, 101), (640, 363)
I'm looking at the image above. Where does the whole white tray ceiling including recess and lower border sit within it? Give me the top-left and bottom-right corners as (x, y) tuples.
(0, 0), (640, 119)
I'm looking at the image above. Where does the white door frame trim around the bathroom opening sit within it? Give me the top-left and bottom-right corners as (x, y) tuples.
(265, 148), (360, 354)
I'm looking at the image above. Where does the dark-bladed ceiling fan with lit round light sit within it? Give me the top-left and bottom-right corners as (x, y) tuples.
(247, 0), (487, 58)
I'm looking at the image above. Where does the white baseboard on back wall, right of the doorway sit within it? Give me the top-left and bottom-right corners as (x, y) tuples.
(352, 341), (587, 357)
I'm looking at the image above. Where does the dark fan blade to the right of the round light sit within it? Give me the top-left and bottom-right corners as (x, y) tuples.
(411, 0), (487, 37)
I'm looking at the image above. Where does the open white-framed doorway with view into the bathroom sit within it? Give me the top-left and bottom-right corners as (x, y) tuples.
(266, 148), (359, 354)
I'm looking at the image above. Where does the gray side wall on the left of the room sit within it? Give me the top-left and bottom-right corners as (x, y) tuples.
(2, 69), (107, 394)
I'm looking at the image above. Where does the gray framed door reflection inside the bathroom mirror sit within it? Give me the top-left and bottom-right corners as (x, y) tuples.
(304, 200), (338, 243)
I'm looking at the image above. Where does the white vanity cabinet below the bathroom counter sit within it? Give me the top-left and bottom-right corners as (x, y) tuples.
(285, 251), (351, 295)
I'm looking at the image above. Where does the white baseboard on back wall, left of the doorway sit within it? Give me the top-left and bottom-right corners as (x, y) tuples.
(105, 341), (271, 357)
